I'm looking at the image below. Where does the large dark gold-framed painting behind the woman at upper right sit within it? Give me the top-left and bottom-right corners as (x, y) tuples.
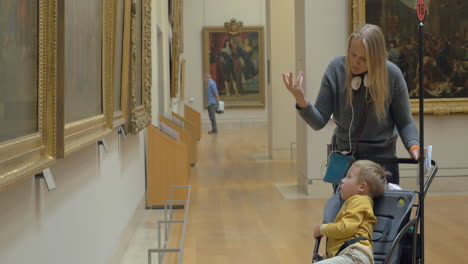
(352, 0), (468, 114)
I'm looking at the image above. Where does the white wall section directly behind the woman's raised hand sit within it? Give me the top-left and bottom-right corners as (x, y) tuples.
(296, 0), (350, 183)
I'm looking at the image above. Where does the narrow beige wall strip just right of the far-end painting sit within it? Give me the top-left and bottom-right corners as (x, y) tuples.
(267, 0), (296, 160)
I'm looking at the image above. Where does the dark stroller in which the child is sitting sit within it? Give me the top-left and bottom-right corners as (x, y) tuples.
(312, 159), (438, 264)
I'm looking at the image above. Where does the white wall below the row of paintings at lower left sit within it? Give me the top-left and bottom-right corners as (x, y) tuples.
(0, 132), (145, 264)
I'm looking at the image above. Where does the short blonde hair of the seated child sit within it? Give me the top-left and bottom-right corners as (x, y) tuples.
(353, 160), (390, 198)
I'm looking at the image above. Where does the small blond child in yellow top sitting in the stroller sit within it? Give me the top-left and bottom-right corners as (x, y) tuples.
(314, 160), (388, 264)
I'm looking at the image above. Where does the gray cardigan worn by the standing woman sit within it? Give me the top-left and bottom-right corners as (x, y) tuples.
(296, 56), (419, 158)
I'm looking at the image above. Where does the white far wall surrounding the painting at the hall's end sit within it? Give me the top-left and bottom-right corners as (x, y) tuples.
(182, 0), (266, 126)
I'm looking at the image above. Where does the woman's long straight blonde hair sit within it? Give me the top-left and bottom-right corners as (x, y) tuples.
(345, 24), (389, 120)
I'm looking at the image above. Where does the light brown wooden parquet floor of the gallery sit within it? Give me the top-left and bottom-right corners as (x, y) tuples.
(167, 127), (468, 264)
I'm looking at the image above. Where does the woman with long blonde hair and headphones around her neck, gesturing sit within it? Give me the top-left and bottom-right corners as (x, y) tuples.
(283, 24), (419, 184)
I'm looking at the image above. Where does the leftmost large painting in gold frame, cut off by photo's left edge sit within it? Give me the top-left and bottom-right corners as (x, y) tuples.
(0, 0), (57, 191)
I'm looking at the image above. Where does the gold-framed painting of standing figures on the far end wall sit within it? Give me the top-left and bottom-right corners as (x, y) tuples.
(203, 19), (265, 108)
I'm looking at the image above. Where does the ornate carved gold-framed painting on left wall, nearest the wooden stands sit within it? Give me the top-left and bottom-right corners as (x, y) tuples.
(123, 0), (152, 134)
